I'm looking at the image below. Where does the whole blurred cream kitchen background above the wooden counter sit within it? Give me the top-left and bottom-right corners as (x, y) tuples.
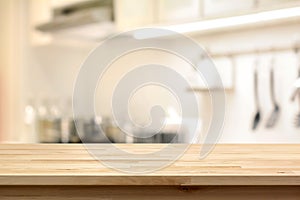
(0, 0), (300, 143)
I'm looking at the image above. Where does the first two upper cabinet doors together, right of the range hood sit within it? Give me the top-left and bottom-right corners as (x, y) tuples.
(114, 0), (201, 30)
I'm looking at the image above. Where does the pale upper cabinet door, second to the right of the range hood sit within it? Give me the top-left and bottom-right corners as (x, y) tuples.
(157, 0), (201, 23)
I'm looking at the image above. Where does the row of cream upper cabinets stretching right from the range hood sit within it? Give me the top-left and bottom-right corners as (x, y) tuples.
(114, 0), (300, 31)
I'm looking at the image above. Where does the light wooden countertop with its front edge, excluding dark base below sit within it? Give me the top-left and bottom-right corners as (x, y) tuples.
(0, 144), (300, 186)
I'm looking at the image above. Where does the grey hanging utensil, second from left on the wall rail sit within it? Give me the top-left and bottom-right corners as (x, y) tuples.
(266, 58), (280, 128)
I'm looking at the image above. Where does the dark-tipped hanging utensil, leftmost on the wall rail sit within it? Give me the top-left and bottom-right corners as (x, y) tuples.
(252, 59), (261, 130)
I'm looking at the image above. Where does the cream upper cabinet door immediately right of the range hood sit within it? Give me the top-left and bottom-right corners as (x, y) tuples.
(114, 0), (155, 30)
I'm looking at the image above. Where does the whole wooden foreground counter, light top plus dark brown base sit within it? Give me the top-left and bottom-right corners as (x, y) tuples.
(0, 144), (300, 199)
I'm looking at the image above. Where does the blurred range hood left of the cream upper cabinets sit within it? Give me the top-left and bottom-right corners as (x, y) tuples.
(36, 0), (115, 39)
